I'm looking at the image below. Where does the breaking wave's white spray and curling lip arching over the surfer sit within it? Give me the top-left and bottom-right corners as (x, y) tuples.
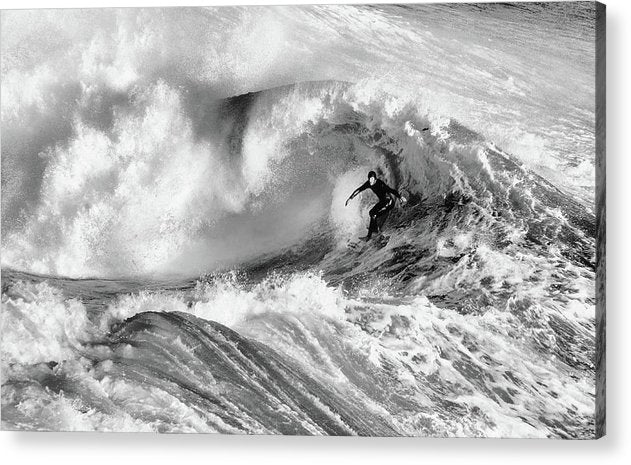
(3, 82), (593, 277)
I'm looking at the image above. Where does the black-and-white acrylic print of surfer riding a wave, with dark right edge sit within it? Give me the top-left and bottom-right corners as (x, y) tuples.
(1, 2), (604, 438)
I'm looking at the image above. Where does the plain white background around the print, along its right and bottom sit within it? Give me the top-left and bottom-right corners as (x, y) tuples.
(0, 0), (631, 465)
